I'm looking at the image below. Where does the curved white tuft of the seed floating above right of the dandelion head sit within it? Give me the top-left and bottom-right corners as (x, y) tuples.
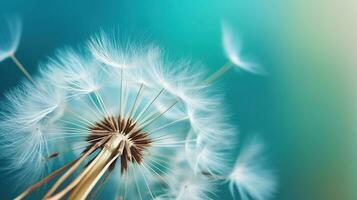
(222, 23), (266, 74)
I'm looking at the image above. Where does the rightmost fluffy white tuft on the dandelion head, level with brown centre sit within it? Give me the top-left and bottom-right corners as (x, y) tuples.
(186, 108), (238, 176)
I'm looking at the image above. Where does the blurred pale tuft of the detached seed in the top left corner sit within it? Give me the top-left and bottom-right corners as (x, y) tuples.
(0, 16), (22, 62)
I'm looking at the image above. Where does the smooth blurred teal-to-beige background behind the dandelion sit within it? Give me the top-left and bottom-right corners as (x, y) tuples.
(0, 0), (357, 200)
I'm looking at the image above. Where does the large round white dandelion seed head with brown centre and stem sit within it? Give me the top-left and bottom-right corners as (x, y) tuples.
(0, 18), (276, 200)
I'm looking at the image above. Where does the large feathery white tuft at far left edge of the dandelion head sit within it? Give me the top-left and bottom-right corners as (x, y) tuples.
(0, 79), (63, 182)
